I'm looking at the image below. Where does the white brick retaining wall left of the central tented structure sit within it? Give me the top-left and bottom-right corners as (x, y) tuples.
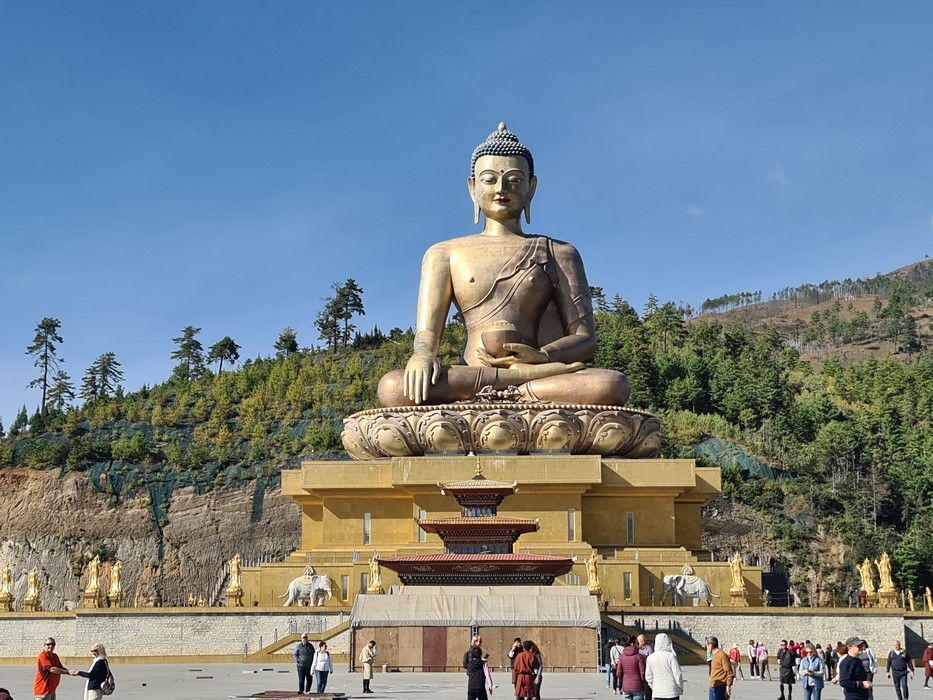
(0, 608), (346, 663)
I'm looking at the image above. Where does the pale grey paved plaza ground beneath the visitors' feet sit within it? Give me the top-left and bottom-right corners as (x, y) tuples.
(0, 664), (920, 700)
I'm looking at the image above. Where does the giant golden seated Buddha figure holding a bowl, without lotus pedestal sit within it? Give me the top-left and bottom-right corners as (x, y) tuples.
(379, 124), (630, 406)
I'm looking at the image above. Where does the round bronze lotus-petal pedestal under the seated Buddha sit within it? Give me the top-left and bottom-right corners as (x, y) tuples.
(341, 403), (661, 459)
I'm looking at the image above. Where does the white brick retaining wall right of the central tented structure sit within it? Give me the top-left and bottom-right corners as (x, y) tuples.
(611, 607), (933, 658)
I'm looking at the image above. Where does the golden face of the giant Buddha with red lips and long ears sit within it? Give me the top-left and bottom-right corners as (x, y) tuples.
(467, 156), (538, 221)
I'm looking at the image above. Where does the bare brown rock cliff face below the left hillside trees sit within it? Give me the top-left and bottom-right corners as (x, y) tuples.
(0, 469), (301, 611)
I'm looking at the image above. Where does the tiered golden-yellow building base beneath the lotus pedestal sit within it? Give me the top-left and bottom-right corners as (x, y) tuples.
(243, 455), (761, 609)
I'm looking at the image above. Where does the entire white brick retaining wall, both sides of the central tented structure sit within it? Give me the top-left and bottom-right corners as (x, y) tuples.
(0, 607), (933, 664)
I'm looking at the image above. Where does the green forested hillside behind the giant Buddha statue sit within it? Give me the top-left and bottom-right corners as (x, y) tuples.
(0, 263), (933, 604)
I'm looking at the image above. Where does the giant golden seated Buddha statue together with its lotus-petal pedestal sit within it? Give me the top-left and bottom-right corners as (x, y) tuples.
(343, 124), (660, 459)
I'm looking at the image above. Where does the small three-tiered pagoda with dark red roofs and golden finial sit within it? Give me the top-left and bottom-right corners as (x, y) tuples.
(379, 460), (573, 586)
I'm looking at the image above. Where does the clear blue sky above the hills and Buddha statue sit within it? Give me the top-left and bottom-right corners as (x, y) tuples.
(0, 0), (933, 427)
